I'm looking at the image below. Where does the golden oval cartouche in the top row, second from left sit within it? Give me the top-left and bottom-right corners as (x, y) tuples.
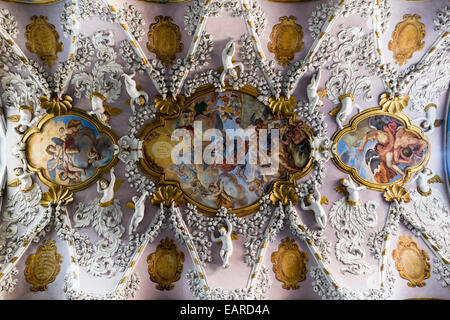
(147, 16), (183, 67)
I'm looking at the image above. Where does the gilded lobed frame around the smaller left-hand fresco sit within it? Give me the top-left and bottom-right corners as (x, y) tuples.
(22, 108), (118, 192)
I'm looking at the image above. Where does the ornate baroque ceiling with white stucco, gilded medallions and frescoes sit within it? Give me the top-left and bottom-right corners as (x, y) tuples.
(0, 0), (450, 299)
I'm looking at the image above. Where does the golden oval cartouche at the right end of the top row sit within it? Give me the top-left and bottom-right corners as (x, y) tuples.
(388, 14), (425, 66)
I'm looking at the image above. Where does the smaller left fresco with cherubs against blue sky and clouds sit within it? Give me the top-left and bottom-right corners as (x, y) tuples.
(24, 111), (115, 189)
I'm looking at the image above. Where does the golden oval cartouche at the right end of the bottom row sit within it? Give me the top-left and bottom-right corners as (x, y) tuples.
(392, 235), (431, 288)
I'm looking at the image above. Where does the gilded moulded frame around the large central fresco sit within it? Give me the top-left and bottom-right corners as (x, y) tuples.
(137, 85), (314, 217)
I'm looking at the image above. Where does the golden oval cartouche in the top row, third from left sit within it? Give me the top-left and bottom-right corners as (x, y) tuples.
(267, 16), (305, 67)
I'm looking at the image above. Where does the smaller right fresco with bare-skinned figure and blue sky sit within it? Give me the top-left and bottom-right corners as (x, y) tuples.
(334, 114), (429, 188)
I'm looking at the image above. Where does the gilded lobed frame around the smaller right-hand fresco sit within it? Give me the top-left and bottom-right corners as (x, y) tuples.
(331, 107), (431, 191)
